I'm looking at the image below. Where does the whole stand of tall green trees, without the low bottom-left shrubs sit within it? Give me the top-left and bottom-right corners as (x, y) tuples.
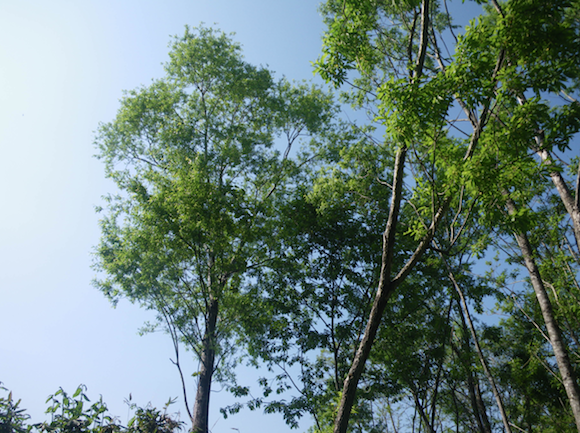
(0, 0), (580, 433)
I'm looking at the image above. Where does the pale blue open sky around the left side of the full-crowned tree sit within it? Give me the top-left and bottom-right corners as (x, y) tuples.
(0, 0), (480, 433)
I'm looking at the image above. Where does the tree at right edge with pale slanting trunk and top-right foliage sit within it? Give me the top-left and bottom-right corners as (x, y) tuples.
(458, 1), (580, 431)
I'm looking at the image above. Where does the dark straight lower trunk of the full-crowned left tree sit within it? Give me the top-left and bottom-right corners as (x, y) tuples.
(191, 296), (218, 433)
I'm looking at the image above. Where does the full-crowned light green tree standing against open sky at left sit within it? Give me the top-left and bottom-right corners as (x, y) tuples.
(96, 24), (335, 433)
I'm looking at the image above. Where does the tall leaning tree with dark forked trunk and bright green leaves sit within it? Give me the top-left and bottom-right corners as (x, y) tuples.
(318, 0), (485, 433)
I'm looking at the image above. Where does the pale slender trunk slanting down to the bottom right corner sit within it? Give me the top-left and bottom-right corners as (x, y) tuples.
(506, 199), (580, 433)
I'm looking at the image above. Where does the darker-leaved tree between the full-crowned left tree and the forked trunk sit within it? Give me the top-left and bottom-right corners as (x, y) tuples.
(234, 125), (390, 429)
